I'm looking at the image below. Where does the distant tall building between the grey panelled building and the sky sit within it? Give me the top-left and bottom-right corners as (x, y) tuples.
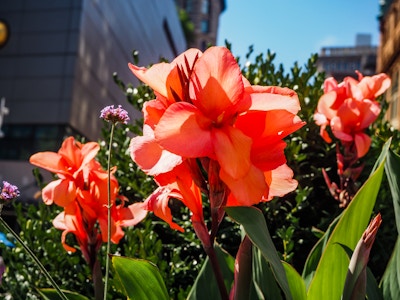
(176, 0), (226, 51)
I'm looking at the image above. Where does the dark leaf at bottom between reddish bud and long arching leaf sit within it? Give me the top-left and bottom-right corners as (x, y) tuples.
(250, 248), (282, 300)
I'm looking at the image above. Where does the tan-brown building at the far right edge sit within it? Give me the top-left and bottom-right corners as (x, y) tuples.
(377, 0), (400, 129)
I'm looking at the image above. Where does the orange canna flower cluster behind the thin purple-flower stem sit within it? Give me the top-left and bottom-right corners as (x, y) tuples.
(30, 137), (146, 261)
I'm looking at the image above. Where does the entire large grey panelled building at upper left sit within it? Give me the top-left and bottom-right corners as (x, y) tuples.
(0, 0), (187, 202)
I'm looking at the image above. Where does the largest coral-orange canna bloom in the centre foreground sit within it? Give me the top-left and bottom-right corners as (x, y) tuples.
(129, 47), (304, 236)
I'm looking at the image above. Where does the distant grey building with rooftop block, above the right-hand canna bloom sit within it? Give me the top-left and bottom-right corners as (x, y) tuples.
(317, 34), (377, 81)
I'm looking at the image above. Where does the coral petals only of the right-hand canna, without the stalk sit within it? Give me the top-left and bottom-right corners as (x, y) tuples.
(314, 72), (390, 158)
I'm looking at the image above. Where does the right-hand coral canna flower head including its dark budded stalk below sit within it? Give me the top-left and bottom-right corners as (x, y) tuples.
(314, 72), (391, 207)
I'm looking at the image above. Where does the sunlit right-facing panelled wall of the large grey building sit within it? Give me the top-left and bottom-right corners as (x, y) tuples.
(69, 0), (186, 139)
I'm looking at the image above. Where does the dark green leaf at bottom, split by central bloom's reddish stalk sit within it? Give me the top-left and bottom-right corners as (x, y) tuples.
(187, 245), (235, 300)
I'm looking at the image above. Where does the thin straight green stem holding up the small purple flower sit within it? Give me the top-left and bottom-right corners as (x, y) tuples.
(104, 123), (115, 300)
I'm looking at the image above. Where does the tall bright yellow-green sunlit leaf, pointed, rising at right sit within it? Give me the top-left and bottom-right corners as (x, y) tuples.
(308, 141), (390, 300)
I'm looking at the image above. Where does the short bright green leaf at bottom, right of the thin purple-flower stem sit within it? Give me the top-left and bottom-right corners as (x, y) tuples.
(112, 256), (169, 300)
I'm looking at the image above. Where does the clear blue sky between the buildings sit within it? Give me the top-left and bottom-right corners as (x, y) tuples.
(217, 0), (379, 70)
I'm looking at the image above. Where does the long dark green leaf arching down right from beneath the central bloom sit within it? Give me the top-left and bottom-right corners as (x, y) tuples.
(225, 206), (292, 299)
